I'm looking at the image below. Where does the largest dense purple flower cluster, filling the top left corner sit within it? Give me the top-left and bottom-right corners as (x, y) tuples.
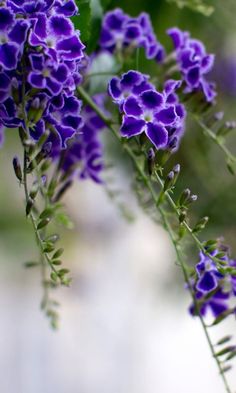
(0, 0), (84, 149)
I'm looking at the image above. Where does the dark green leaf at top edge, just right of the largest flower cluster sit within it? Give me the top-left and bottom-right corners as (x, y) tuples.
(71, 0), (91, 42)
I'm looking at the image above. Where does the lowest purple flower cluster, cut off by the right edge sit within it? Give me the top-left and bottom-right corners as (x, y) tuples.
(190, 250), (236, 317)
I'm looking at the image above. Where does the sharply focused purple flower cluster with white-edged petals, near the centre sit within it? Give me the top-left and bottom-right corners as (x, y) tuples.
(108, 70), (185, 150)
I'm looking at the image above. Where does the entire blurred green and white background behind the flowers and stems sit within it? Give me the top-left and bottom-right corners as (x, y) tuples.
(0, 0), (236, 393)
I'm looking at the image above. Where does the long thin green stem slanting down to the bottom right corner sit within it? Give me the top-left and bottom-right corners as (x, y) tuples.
(77, 87), (232, 393)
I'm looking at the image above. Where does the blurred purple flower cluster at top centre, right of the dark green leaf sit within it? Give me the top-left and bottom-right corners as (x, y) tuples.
(100, 8), (165, 62)
